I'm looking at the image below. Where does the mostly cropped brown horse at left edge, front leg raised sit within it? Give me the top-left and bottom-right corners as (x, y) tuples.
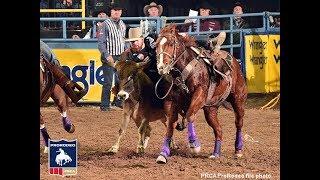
(40, 55), (75, 153)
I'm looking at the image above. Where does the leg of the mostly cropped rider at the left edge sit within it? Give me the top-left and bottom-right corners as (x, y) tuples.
(40, 40), (86, 103)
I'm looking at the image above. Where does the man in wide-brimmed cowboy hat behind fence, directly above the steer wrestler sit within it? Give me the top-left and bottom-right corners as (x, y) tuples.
(143, 2), (163, 34)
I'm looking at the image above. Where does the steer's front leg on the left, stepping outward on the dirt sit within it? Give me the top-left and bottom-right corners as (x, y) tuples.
(108, 101), (134, 154)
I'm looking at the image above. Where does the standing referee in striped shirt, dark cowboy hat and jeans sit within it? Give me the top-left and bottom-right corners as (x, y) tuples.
(98, 3), (126, 111)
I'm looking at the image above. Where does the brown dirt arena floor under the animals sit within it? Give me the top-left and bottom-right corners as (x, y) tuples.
(40, 95), (280, 180)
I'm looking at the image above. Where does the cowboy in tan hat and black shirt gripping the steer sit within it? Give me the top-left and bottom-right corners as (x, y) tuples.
(120, 27), (160, 83)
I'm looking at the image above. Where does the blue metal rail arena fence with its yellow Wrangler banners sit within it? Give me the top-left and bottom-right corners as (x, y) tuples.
(40, 11), (280, 103)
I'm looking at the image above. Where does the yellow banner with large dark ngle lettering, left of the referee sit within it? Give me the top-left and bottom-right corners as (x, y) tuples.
(53, 49), (113, 102)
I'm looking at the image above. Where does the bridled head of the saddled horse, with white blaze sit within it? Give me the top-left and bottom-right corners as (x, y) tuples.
(156, 25), (183, 75)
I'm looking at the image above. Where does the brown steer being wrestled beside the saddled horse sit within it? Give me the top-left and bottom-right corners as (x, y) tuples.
(108, 59), (177, 154)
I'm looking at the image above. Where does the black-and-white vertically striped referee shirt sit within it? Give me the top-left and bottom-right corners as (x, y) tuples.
(98, 19), (126, 60)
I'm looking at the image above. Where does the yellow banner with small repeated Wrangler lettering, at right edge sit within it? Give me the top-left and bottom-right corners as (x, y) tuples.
(244, 35), (280, 93)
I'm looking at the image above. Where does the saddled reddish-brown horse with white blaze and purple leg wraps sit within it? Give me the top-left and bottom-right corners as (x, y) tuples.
(156, 25), (247, 163)
